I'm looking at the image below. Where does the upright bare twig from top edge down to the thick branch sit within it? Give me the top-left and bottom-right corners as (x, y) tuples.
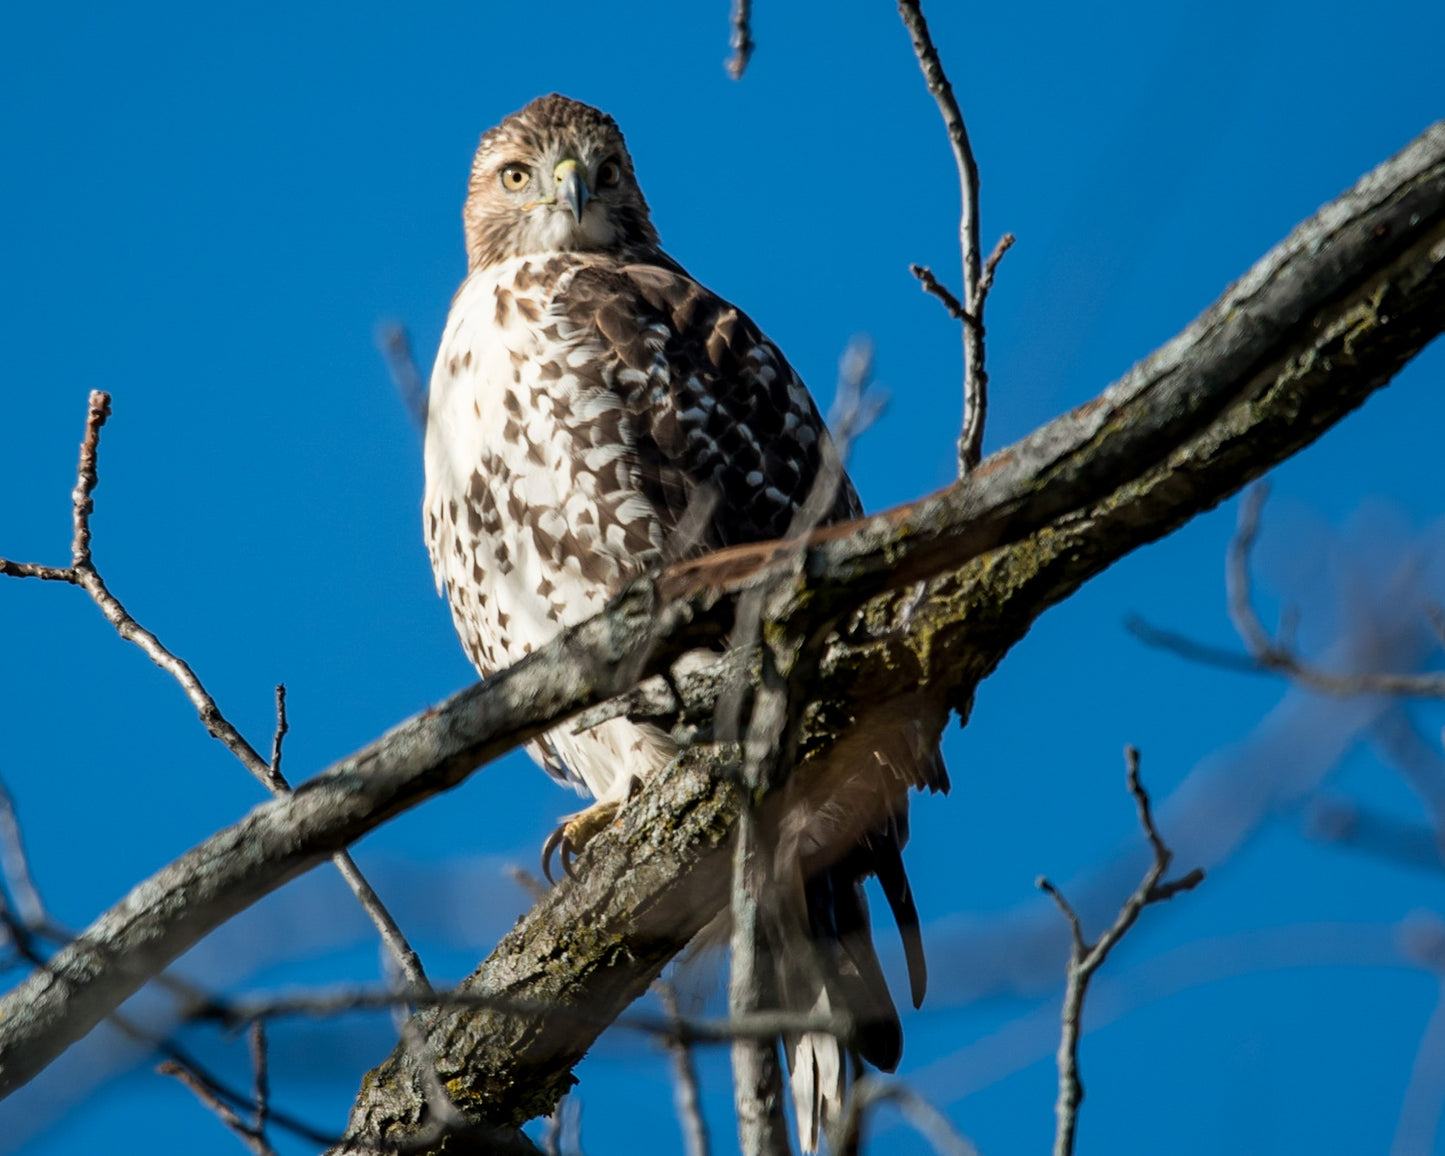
(899, 0), (1014, 477)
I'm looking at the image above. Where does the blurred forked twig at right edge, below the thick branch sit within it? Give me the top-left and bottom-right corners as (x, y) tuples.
(1124, 483), (1445, 698)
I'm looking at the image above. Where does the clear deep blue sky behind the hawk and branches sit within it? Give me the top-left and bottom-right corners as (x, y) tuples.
(0, 0), (1445, 1156)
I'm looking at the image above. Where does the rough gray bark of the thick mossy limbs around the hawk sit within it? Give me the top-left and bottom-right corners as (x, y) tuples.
(0, 114), (1445, 1152)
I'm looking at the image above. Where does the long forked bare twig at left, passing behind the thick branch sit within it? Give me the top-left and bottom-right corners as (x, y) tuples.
(0, 390), (426, 987)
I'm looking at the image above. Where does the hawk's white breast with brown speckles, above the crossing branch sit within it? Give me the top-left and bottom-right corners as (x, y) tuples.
(425, 257), (660, 672)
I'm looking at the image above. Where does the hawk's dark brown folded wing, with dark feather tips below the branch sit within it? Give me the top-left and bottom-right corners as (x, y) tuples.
(553, 264), (948, 1121)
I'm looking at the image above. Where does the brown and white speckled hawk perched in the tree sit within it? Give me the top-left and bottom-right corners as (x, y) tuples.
(423, 94), (948, 1150)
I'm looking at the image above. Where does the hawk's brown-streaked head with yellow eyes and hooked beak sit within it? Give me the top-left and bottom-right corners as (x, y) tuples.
(462, 92), (657, 270)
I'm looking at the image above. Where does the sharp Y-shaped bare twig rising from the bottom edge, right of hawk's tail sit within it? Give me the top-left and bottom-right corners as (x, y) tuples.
(1038, 747), (1204, 1156)
